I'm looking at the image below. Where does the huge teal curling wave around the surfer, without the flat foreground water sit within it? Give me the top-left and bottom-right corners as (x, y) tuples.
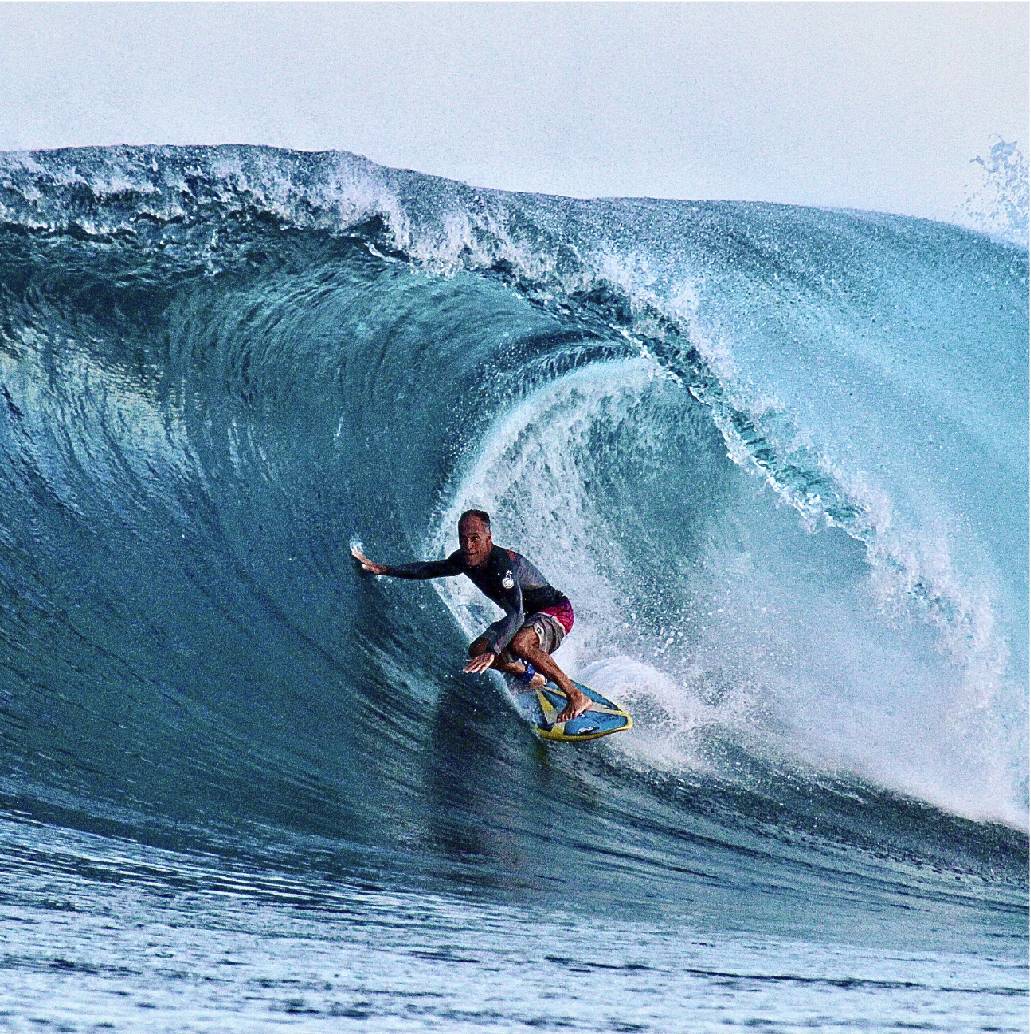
(0, 147), (1028, 943)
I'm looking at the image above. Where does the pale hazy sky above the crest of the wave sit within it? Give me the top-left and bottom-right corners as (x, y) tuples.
(0, 2), (1028, 218)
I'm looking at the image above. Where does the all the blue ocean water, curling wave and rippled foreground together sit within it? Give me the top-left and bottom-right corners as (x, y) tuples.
(0, 147), (1028, 1034)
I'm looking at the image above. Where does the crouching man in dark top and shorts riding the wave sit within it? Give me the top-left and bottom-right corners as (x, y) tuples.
(351, 510), (590, 722)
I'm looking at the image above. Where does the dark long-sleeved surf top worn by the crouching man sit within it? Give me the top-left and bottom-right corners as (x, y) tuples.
(386, 546), (569, 653)
